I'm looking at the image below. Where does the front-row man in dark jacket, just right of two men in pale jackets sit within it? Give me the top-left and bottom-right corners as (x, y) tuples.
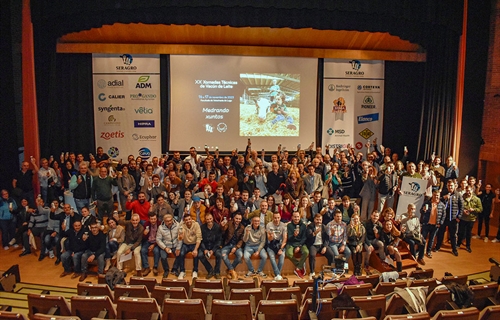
(198, 212), (222, 279)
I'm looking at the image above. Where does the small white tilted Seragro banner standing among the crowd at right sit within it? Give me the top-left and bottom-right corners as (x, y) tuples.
(396, 177), (427, 219)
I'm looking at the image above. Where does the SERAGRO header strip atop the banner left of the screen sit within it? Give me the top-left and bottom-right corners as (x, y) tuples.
(92, 53), (160, 74)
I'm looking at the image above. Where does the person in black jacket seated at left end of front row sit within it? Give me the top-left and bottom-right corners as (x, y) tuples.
(60, 220), (88, 279)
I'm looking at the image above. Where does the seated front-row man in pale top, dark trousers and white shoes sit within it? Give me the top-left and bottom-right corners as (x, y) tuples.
(266, 212), (288, 280)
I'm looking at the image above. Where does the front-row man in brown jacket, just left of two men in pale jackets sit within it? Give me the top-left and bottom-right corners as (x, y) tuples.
(141, 212), (160, 277)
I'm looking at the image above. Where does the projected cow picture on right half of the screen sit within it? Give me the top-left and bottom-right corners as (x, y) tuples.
(240, 73), (300, 137)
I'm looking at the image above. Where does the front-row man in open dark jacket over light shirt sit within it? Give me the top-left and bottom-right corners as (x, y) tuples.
(306, 213), (333, 279)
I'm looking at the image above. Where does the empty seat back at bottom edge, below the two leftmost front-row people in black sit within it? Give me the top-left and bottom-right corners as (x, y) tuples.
(71, 296), (116, 319)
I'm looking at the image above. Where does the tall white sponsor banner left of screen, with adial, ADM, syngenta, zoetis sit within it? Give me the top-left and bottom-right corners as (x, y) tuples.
(92, 54), (161, 162)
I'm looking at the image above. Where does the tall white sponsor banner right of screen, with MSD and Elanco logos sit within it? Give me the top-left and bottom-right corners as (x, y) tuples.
(322, 60), (384, 150)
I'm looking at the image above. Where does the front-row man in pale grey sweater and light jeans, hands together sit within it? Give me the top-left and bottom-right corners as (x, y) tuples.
(243, 216), (267, 278)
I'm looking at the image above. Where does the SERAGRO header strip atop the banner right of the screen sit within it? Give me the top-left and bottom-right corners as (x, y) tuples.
(324, 59), (385, 79)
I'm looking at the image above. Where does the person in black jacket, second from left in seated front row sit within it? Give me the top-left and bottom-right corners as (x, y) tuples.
(79, 222), (106, 282)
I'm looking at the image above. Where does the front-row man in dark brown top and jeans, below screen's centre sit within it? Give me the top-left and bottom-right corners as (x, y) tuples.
(221, 211), (245, 279)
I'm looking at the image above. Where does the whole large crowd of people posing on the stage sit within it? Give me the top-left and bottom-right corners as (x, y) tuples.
(0, 139), (500, 281)
